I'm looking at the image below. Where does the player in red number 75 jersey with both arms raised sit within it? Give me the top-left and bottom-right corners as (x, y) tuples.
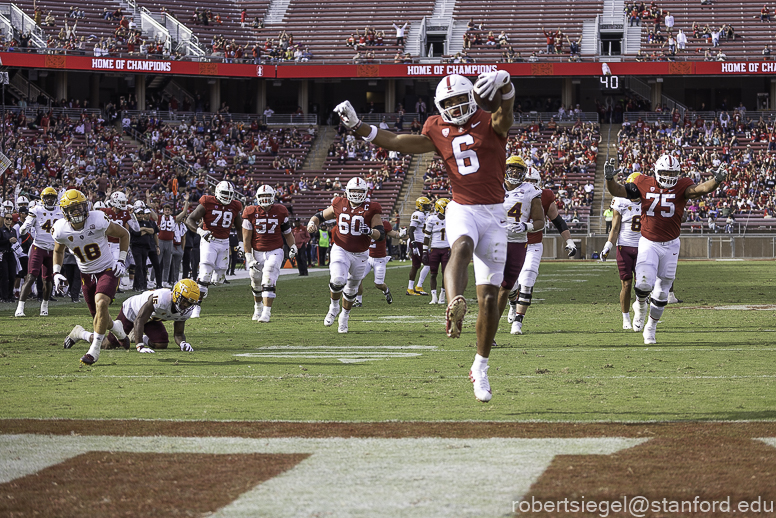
(604, 155), (728, 344)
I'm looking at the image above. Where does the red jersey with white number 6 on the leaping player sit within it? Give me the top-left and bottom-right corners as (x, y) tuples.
(423, 108), (507, 205)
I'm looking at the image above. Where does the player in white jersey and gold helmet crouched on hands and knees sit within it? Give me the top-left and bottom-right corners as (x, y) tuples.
(65, 279), (199, 353)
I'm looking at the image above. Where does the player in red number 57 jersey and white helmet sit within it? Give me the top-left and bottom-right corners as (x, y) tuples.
(242, 185), (297, 322)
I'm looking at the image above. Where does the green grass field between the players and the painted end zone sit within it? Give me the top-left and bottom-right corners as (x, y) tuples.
(0, 261), (776, 421)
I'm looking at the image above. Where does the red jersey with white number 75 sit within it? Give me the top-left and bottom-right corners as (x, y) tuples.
(633, 174), (695, 242)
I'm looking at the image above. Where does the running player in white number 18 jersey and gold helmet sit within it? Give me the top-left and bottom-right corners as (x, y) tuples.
(51, 189), (129, 365)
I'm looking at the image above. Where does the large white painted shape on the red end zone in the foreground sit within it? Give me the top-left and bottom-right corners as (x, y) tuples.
(0, 435), (649, 518)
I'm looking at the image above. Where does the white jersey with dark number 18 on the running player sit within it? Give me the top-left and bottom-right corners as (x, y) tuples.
(51, 210), (114, 273)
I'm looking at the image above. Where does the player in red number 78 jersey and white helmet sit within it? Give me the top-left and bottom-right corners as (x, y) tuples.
(186, 180), (242, 318)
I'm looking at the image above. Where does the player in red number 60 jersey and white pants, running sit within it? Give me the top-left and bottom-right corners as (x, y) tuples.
(307, 176), (385, 333)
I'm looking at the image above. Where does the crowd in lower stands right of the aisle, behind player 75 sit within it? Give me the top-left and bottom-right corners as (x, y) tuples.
(618, 107), (776, 225)
